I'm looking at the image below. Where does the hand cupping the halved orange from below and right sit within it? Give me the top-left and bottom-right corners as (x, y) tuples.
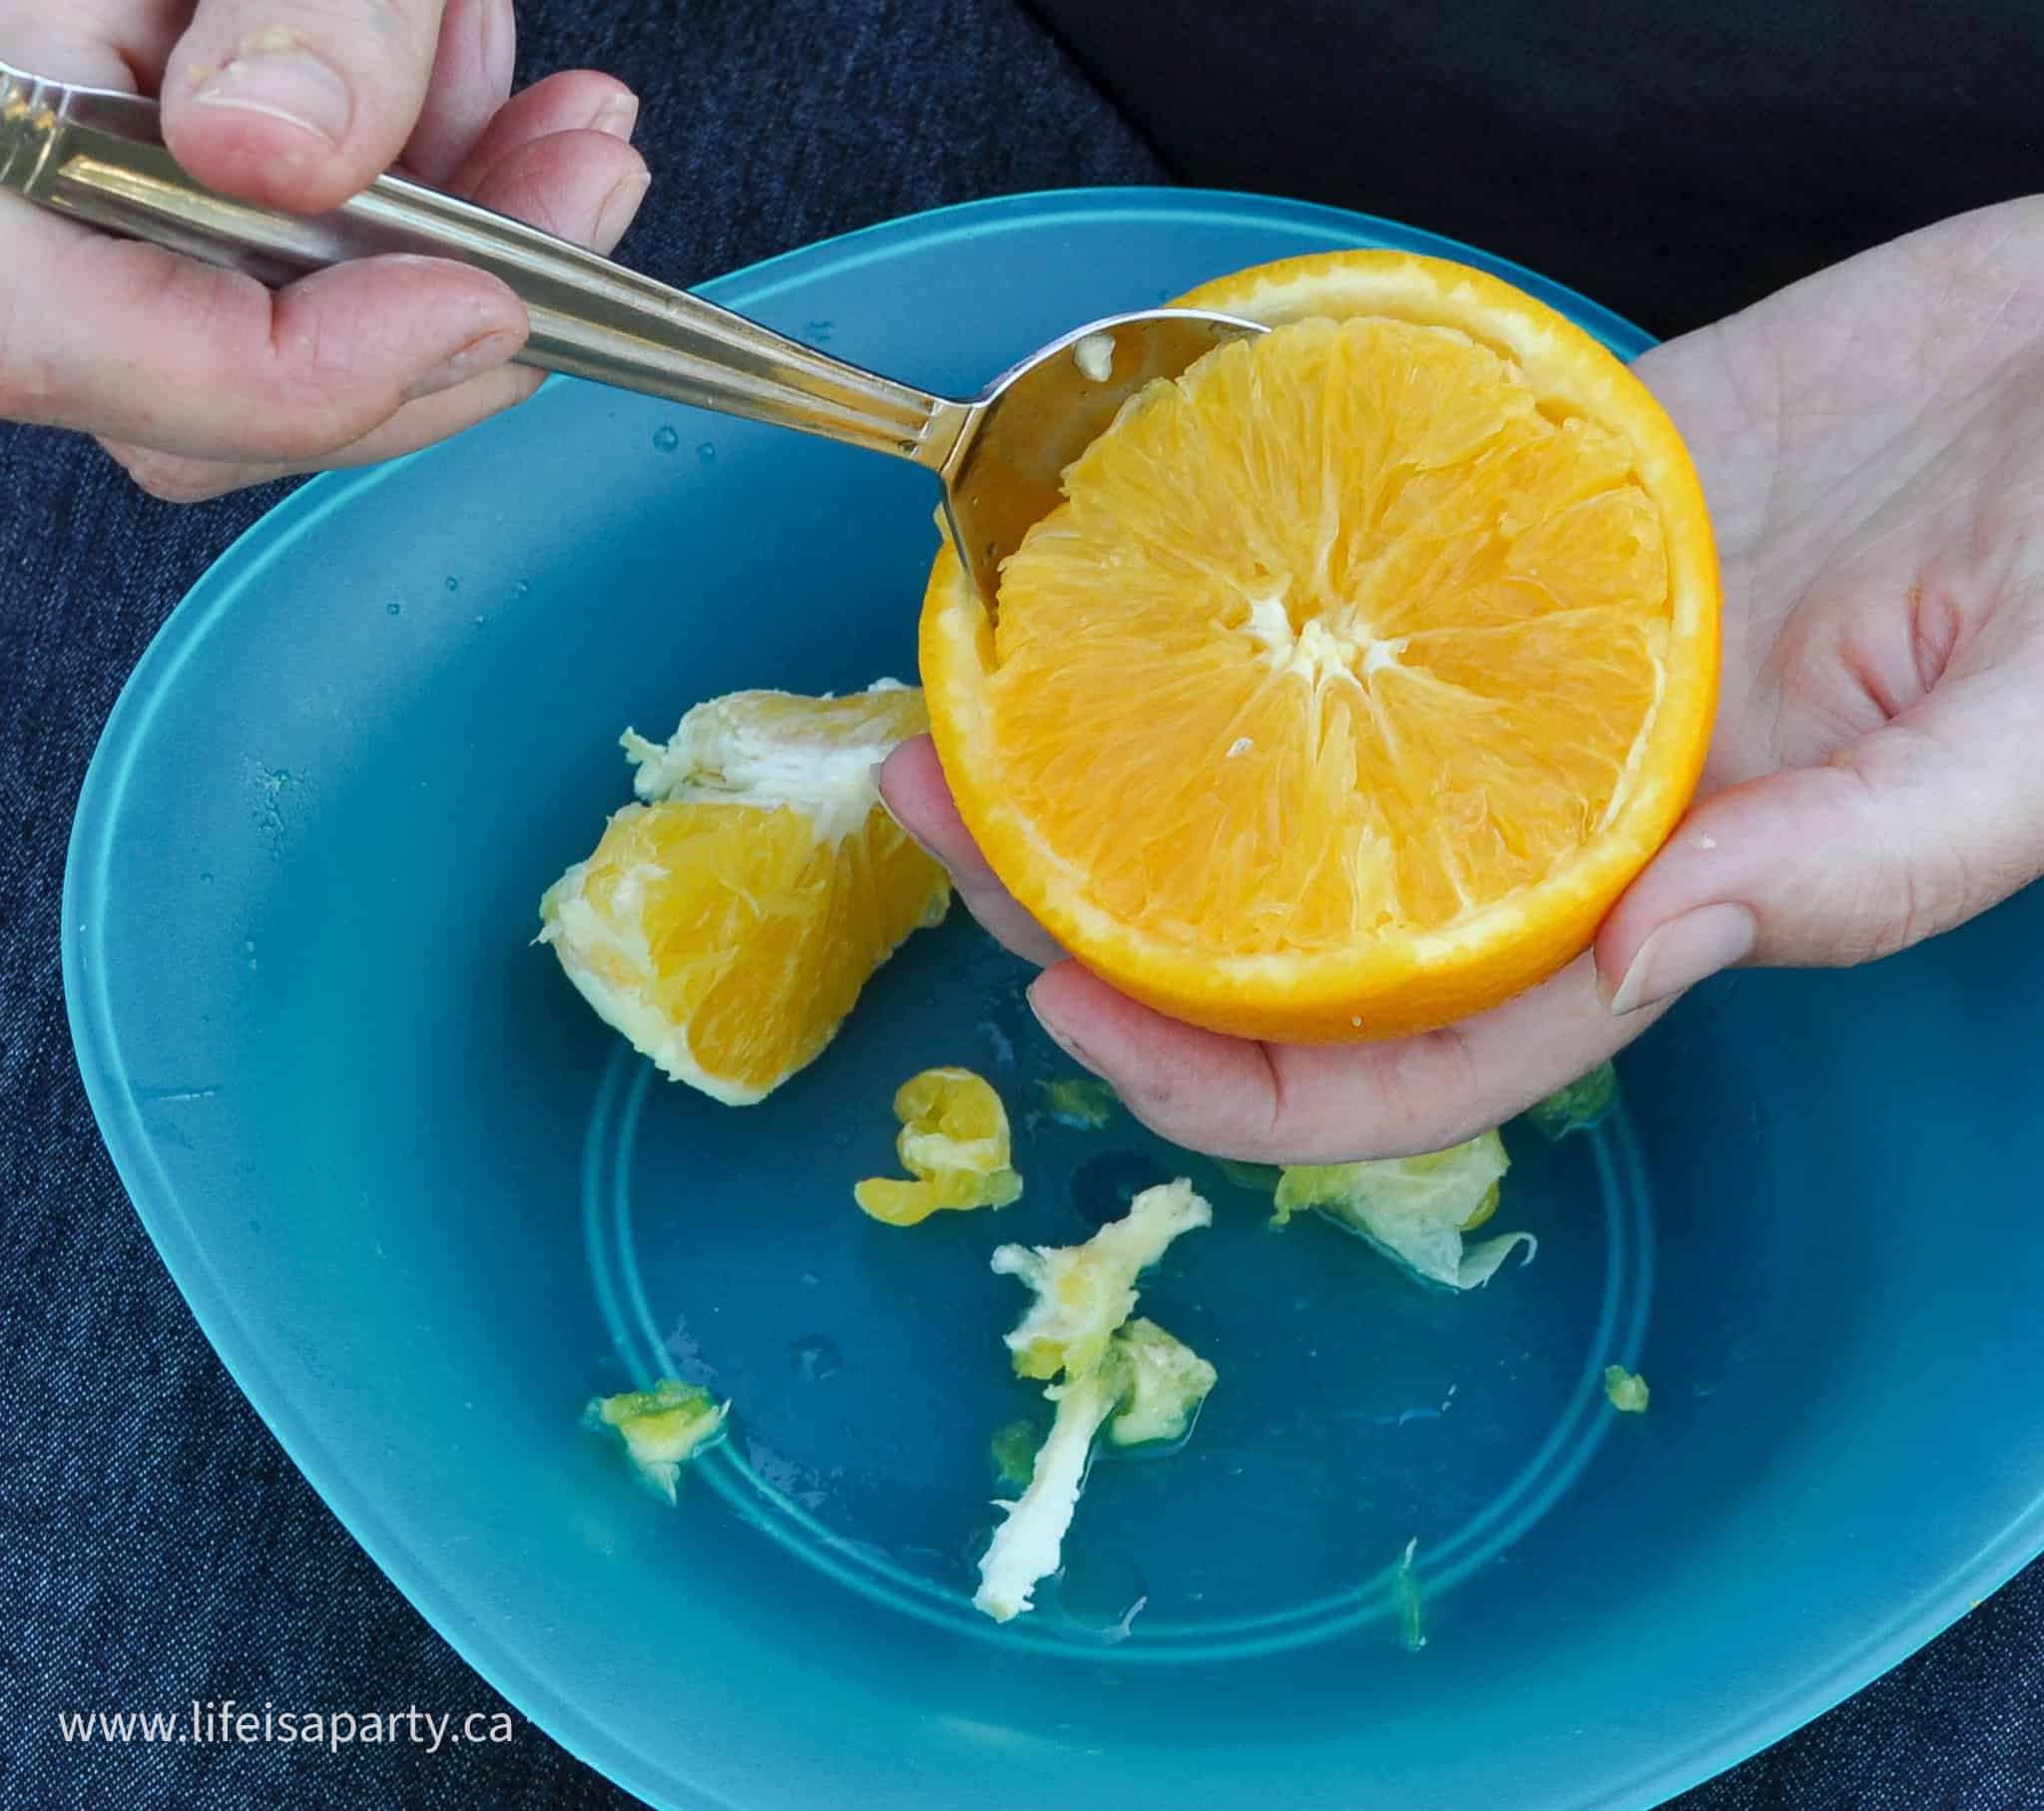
(881, 199), (2044, 1163)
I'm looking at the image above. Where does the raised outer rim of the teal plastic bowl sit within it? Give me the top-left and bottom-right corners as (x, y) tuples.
(59, 184), (2044, 1811)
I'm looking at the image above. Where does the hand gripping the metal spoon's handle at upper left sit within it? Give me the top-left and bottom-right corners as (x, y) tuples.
(0, 0), (648, 501)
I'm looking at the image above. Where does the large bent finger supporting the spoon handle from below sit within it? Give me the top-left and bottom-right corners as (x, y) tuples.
(0, 209), (525, 462)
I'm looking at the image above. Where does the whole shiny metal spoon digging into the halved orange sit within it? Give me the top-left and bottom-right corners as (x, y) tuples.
(0, 64), (1264, 614)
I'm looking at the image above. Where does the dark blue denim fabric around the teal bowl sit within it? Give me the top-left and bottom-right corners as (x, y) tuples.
(0, 0), (2044, 1811)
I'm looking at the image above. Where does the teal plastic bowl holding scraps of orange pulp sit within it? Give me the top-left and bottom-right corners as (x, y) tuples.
(63, 191), (2044, 1811)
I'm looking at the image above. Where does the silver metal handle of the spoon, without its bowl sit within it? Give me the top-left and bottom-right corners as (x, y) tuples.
(0, 64), (967, 470)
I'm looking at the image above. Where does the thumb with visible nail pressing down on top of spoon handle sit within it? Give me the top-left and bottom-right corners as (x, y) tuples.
(164, 0), (455, 213)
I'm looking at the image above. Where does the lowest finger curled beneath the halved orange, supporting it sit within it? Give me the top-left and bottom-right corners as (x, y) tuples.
(1028, 957), (1660, 1163)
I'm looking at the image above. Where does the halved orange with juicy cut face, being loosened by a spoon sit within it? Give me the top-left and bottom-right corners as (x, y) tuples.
(922, 251), (1719, 1041)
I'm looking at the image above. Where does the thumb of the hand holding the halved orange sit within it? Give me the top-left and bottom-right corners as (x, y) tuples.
(1596, 675), (2044, 1014)
